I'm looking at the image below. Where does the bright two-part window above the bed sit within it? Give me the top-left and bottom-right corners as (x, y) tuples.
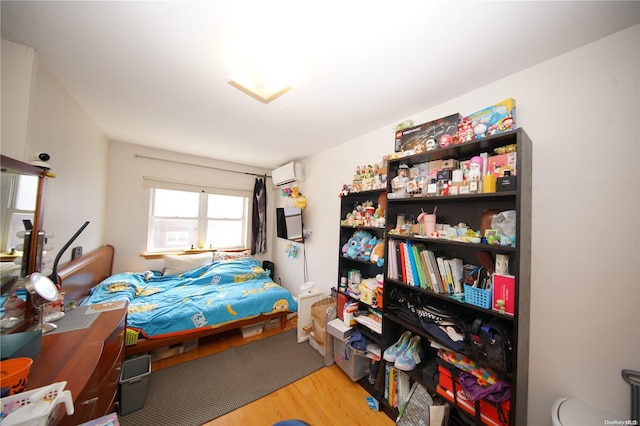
(147, 188), (249, 252)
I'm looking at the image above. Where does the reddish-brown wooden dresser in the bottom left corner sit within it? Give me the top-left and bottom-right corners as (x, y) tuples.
(26, 303), (127, 425)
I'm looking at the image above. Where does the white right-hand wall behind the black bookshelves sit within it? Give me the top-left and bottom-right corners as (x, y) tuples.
(301, 25), (640, 425)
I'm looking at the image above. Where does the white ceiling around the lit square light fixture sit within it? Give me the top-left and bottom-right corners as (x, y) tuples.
(1, 0), (640, 169)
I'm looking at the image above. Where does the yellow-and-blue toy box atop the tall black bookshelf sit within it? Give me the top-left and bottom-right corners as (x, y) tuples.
(457, 98), (516, 143)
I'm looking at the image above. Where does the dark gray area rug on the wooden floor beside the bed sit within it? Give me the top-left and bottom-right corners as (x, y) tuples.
(118, 329), (324, 426)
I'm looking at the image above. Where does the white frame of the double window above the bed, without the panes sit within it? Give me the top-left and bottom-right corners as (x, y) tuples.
(144, 177), (253, 253)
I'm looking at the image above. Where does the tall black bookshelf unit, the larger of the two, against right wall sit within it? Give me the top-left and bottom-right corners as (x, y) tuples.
(380, 129), (532, 425)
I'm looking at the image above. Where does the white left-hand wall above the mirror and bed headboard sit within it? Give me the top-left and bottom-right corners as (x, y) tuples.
(0, 40), (109, 263)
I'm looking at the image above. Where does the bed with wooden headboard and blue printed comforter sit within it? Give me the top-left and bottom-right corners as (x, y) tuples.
(58, 246), (297, 356)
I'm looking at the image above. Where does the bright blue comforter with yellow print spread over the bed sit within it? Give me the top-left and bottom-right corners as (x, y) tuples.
(83, 258), (298, 338)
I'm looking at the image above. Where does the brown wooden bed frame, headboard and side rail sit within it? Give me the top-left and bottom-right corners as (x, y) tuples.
(58, 245), (290, 357)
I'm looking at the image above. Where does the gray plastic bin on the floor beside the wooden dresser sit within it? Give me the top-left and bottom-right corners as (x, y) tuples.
(119, 355), (151, 415)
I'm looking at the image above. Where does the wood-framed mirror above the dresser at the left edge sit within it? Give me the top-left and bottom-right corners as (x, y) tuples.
(0, 155), (46, 334)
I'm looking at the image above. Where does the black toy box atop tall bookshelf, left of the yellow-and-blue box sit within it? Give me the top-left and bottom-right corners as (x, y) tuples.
(395, 114), (461, 154)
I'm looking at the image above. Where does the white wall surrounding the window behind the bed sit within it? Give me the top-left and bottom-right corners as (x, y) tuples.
(105, 141), (277, 272)
